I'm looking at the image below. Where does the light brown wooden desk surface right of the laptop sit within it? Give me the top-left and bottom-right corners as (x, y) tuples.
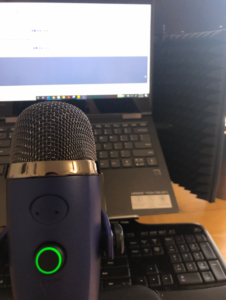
(139, 184), (226, 261)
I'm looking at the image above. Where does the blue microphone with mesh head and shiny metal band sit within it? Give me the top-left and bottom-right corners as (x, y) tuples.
(7, 101), (101, 300)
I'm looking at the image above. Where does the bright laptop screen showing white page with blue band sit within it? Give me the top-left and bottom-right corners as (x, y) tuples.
(0, 3), (151, 101)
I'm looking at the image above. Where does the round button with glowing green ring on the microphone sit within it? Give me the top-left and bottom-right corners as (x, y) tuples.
(35, 244), (65, 275)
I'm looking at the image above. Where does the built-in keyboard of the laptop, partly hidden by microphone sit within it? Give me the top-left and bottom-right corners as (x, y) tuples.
(0, 122), (158, 175)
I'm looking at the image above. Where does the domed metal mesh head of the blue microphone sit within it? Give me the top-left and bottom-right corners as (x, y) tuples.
(10, 101), (96, 163)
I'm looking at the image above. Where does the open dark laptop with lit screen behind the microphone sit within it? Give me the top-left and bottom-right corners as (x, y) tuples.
(0, 0), (178, 226)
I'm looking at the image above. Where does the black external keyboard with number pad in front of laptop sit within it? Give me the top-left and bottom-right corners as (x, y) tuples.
(0, 220), (226, 300)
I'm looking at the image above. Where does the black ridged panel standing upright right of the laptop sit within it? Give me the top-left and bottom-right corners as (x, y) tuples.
(153, 30), (226, 202)
